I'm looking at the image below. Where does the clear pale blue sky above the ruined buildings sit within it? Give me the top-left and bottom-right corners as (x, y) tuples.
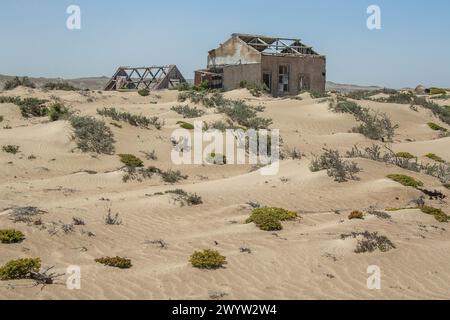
(0, 0), (450, 88)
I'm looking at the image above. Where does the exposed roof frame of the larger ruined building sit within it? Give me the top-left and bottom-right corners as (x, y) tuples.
(232, 33), (318, 55)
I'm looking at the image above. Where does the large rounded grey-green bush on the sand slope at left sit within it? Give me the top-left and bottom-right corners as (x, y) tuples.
(70, 116), (115, 154)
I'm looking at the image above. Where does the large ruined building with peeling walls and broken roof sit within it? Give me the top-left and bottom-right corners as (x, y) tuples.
(194, 33), (326, 96)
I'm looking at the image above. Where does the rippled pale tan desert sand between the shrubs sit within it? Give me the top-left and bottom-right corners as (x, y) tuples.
(0, 87), (450, 299)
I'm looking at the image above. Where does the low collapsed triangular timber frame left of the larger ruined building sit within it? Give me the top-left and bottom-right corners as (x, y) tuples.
(104, 64), (186, 91)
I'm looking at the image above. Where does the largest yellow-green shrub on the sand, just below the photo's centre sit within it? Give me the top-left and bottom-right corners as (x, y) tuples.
(245, 207), (297, 231)
